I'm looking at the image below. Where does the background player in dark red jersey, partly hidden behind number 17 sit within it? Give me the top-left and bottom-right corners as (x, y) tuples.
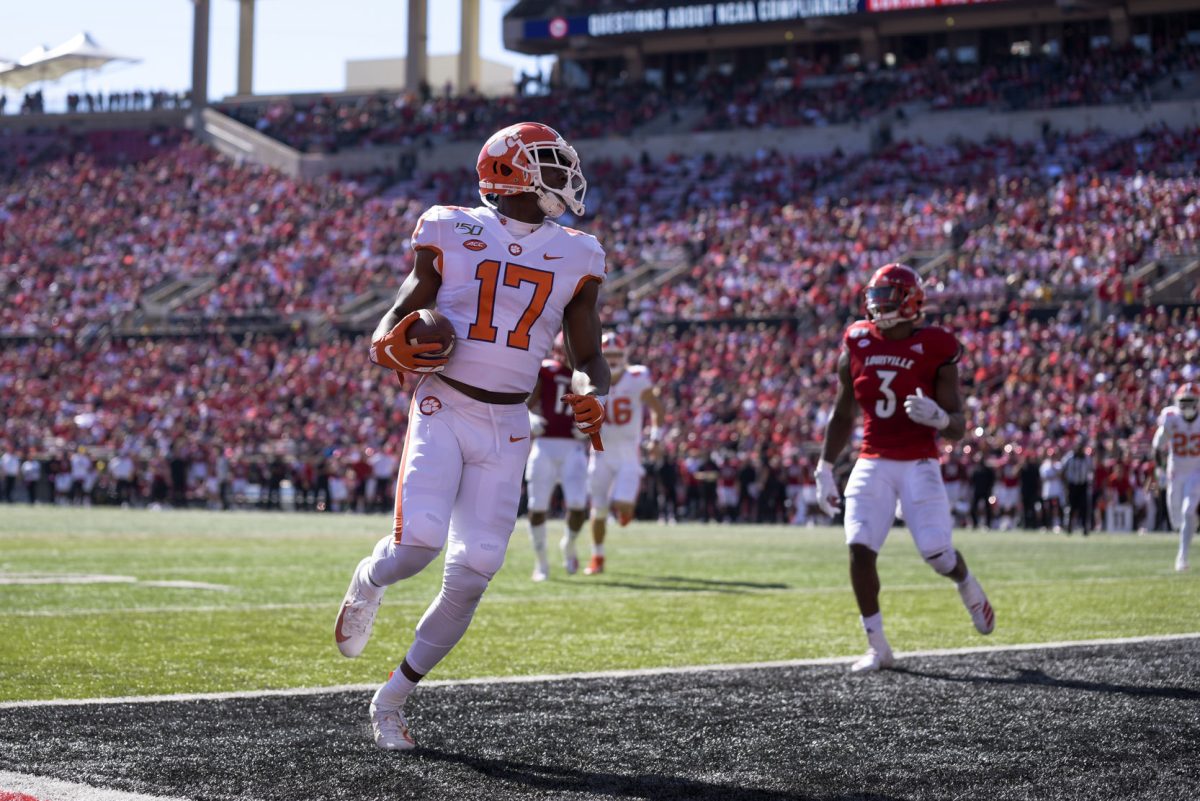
(526, 354), (588, 582)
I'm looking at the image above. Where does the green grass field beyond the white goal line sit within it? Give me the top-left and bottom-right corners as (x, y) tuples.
(0, 506), (1200, 701)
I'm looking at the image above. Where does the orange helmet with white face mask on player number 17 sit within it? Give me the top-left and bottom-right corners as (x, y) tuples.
(475, 122), (588, 217)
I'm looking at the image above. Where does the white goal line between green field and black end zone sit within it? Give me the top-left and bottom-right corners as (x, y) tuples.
(0, 632), (1200, 709)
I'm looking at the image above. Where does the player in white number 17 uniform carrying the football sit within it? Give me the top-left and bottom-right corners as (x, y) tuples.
(334, 122), (610, 751)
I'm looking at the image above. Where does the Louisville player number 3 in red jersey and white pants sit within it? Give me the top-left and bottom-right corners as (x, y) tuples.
(815, 264), (996, 673)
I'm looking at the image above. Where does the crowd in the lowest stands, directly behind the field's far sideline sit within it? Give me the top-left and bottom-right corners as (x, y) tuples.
(0, 306), (1185, 526)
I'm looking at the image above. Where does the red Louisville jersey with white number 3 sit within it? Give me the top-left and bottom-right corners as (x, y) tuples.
(844, 320), (960, 460)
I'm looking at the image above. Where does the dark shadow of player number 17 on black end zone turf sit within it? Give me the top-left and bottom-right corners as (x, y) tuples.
(415, 747), (898, 801)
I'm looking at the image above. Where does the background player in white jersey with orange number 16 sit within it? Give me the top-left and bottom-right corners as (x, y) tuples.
(583, 331), (666, 576)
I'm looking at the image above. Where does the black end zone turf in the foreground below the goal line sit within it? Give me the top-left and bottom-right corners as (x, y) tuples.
(0, 639), (1200, 801)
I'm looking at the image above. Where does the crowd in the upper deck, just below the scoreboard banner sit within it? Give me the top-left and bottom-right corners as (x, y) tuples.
(211, 44), (1200, 152)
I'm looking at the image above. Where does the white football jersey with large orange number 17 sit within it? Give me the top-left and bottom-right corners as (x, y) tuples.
(413, 206), (605, 392)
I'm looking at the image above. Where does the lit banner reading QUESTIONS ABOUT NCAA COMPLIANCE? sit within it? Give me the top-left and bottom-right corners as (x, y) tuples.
(523, 0), (1003, 40)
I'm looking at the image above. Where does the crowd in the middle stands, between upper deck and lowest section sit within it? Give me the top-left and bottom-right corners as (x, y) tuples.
(0, 130), (1200, 336)
